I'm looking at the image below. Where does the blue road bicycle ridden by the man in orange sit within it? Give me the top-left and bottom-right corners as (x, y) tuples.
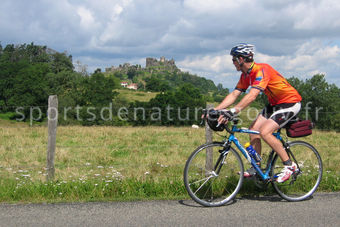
(184, 110), (323, 207)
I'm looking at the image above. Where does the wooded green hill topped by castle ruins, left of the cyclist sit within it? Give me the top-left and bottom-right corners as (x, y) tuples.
(0, 43), (228, 125)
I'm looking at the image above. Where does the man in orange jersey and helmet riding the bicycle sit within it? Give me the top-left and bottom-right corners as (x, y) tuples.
(215, 43), (302, 182)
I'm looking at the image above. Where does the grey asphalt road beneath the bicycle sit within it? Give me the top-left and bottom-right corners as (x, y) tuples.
(0, 193), (340, 227)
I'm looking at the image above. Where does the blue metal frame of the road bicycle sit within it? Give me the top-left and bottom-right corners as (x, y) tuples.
(227, 125), (282, 180)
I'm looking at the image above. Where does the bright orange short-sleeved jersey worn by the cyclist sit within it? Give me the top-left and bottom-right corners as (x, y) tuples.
(236, 63), (302, 106)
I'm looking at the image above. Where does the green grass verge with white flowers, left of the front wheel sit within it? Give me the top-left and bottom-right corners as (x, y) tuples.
(0, 177), (186, 202)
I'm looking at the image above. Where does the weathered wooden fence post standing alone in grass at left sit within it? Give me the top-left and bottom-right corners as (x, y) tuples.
(46, 95), (58, 181)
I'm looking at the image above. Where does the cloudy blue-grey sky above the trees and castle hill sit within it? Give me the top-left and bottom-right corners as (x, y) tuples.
(0, 0), (340, 88)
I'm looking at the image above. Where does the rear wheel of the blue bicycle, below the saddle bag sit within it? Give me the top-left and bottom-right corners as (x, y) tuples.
(271, 141), (323, 202)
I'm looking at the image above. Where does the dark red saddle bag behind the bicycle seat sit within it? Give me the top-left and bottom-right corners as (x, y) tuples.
(286, 120), (314, 138)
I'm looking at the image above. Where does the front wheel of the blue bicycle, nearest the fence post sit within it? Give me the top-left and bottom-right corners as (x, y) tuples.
(184, 142), (244, 207)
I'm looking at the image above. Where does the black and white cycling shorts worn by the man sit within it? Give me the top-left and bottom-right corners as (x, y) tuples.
(261, 102), (301, 128)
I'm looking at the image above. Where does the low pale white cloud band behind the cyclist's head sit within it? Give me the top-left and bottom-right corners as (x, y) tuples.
(178, 40), (340, 88)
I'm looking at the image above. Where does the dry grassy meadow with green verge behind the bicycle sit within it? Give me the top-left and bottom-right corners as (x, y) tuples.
(0, 124), (340, 202)
